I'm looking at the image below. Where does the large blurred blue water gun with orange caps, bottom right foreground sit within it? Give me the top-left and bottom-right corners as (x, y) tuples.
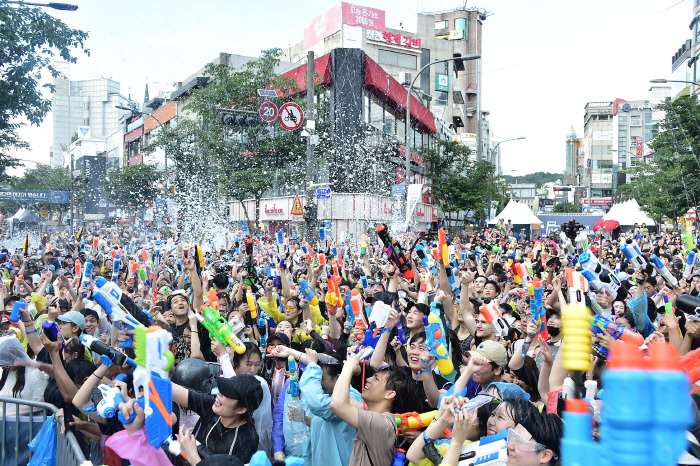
(561, 342), (692, 466)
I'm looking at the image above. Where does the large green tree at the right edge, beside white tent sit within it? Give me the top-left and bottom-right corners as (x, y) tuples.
(618, 96), (700, 218)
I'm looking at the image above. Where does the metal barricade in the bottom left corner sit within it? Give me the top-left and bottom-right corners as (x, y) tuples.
(0, 397), (85, 466)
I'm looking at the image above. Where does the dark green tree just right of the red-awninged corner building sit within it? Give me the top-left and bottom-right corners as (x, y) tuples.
(421, 140), (502, 221)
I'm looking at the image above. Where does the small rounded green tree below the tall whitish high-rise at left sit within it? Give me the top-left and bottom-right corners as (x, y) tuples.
(104, 163), (162, 210)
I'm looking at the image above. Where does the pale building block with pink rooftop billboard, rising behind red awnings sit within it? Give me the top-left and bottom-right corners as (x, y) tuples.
(285, 3), (488, 158)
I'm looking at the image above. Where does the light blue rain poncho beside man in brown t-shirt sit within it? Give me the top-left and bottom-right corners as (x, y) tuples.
(299, 362), (362, 466)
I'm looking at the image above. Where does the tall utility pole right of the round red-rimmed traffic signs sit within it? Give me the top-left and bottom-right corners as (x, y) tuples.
(304, 50), (318, 244)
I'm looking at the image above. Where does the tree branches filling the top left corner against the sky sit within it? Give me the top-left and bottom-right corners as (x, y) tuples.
(0, 0), (89, 175)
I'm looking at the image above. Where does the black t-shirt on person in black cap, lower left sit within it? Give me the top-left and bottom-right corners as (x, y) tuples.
(187, 390), (258, 463)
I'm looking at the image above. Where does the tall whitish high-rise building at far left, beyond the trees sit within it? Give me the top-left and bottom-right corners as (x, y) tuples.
(50, 62), (128, 167)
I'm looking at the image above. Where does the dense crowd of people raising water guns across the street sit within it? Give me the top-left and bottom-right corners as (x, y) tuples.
(0, 221), (700, 466)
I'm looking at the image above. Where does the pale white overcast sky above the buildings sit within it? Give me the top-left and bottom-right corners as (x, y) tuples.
(10, 0), (693, 176)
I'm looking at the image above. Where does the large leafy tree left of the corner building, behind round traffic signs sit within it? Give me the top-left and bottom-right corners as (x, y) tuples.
(155, 49), (319, 235)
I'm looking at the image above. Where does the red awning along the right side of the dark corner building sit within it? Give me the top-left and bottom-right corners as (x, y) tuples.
(365, 55), (437, 133)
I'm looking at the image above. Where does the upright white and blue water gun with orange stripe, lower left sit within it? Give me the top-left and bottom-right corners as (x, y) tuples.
(119, 325), (179, 452)
